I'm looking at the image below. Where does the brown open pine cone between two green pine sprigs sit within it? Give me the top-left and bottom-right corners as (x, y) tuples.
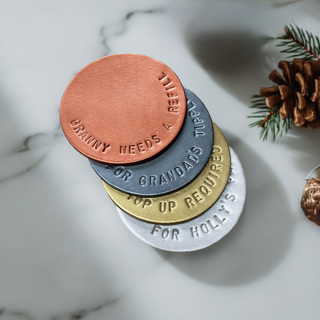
(260, 59), (320, 129)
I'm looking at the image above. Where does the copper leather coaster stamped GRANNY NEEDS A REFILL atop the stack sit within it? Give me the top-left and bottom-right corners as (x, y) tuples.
(60, 54), (186, 164)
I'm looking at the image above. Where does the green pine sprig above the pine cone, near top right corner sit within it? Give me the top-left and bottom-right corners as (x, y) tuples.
(277, 23), (320, 60)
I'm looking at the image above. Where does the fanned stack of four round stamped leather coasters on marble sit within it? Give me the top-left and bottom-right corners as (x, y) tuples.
(60, 54), (246, 251)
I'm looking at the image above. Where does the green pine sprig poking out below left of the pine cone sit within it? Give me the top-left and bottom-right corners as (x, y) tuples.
(248, 95), (292, 141)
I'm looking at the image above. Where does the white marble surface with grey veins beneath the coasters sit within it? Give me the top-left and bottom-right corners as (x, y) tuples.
(0, 0), (320, 320)
